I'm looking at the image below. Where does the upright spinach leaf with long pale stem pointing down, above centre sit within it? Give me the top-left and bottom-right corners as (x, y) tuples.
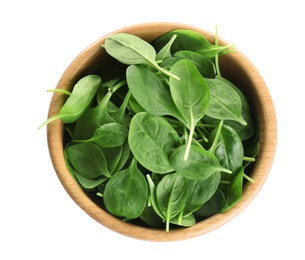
(169, 60), (210, 160)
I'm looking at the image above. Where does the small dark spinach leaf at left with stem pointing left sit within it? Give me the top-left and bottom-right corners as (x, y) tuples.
(72, 122), (128, 147)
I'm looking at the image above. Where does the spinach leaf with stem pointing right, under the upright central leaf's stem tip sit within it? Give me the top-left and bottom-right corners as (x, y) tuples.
(170, 145), (231, 180)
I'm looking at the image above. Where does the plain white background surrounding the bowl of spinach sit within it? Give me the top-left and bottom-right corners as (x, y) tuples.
(0, 0), (305, 260)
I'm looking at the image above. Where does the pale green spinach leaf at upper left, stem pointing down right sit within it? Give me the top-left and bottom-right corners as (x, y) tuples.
(104, 33), (179, 80)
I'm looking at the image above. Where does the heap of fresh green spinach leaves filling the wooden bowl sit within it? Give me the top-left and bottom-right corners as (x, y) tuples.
(41, 30), (258, 231)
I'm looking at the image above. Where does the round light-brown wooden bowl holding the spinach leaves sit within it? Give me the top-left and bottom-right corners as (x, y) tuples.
(47, 23), (277, 241)
